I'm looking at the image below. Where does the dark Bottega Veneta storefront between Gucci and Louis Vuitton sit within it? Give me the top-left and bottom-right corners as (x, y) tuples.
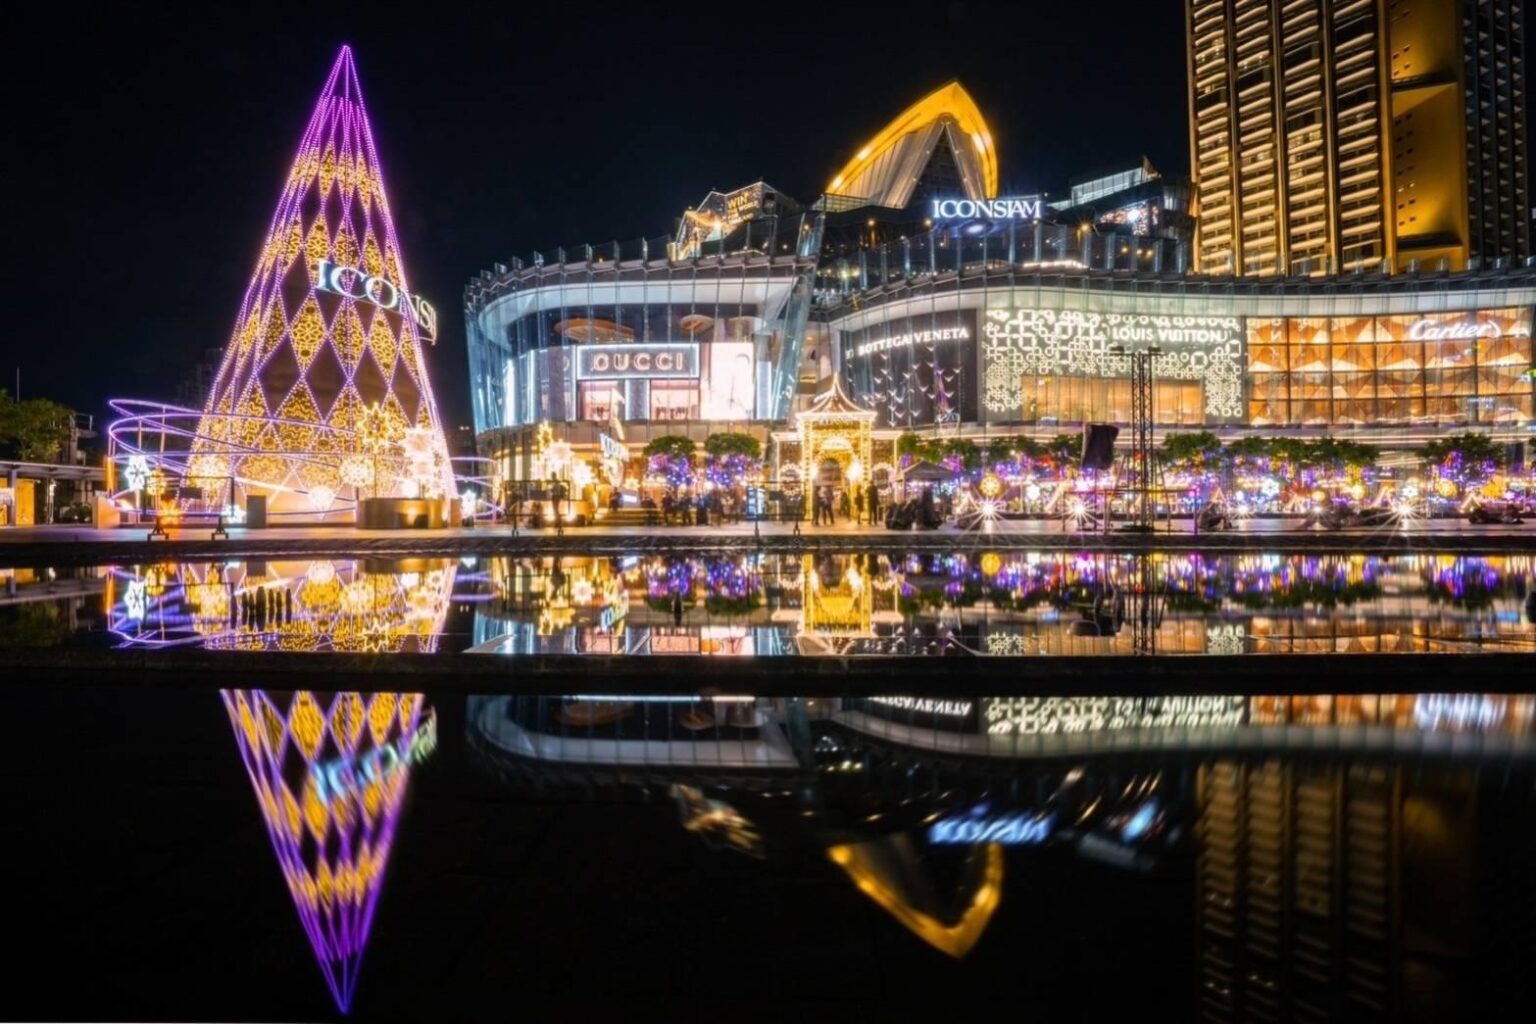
(842, 310), (977, 427)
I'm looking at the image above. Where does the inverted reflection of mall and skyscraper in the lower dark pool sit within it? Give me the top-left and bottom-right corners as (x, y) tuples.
(465, 694), (1536, 976)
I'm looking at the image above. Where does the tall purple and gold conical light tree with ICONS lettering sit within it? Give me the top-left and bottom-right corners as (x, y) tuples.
(186, 46), (453, 513)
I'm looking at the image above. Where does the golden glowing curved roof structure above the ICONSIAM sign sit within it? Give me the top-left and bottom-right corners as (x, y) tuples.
(826, 81), (997, 209)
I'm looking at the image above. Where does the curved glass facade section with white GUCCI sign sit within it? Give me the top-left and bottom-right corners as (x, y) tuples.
(465, 218), (819, 433)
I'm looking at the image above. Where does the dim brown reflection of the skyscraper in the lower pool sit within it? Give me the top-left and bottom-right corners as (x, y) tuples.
(1197, 758), (1530, 1021)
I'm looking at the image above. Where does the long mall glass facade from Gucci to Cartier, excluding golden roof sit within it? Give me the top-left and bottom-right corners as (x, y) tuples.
(467, 196), (1536, 438)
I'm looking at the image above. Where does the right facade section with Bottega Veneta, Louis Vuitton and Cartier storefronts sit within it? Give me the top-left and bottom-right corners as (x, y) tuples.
(819, 260), (1536, 439)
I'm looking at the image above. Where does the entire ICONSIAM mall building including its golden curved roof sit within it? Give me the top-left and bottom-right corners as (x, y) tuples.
(465, 83), (1536, 509)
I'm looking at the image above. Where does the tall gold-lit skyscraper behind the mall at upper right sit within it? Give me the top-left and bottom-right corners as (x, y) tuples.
(1186, 0), (1530, 275)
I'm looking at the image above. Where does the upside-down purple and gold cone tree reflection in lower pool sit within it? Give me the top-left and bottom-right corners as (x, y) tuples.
(221, 689), (436, 1012)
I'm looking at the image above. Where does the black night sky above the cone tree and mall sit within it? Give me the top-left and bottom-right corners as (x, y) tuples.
(0, 0), (1189, 428)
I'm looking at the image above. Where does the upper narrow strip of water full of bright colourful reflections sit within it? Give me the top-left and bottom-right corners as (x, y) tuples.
(0, 551), (1536, 656)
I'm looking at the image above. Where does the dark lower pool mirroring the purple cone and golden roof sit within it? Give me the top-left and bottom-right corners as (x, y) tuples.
(3, 684), (1536, 1021)
